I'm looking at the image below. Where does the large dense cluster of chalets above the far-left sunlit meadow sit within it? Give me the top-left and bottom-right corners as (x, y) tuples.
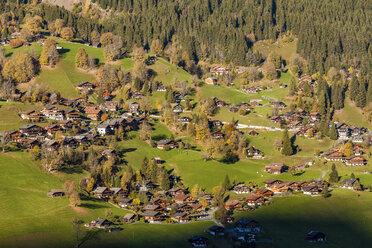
(0, 106), (144, 150)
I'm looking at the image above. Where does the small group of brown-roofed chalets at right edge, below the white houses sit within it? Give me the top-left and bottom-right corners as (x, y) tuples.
(323, 143), (367, 166)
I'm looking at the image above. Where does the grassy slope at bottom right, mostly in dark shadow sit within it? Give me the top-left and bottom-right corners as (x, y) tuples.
(236, 190), (372, 248)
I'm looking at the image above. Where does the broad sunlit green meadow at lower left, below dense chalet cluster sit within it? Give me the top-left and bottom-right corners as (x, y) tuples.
(0, 152), (131, 245)
